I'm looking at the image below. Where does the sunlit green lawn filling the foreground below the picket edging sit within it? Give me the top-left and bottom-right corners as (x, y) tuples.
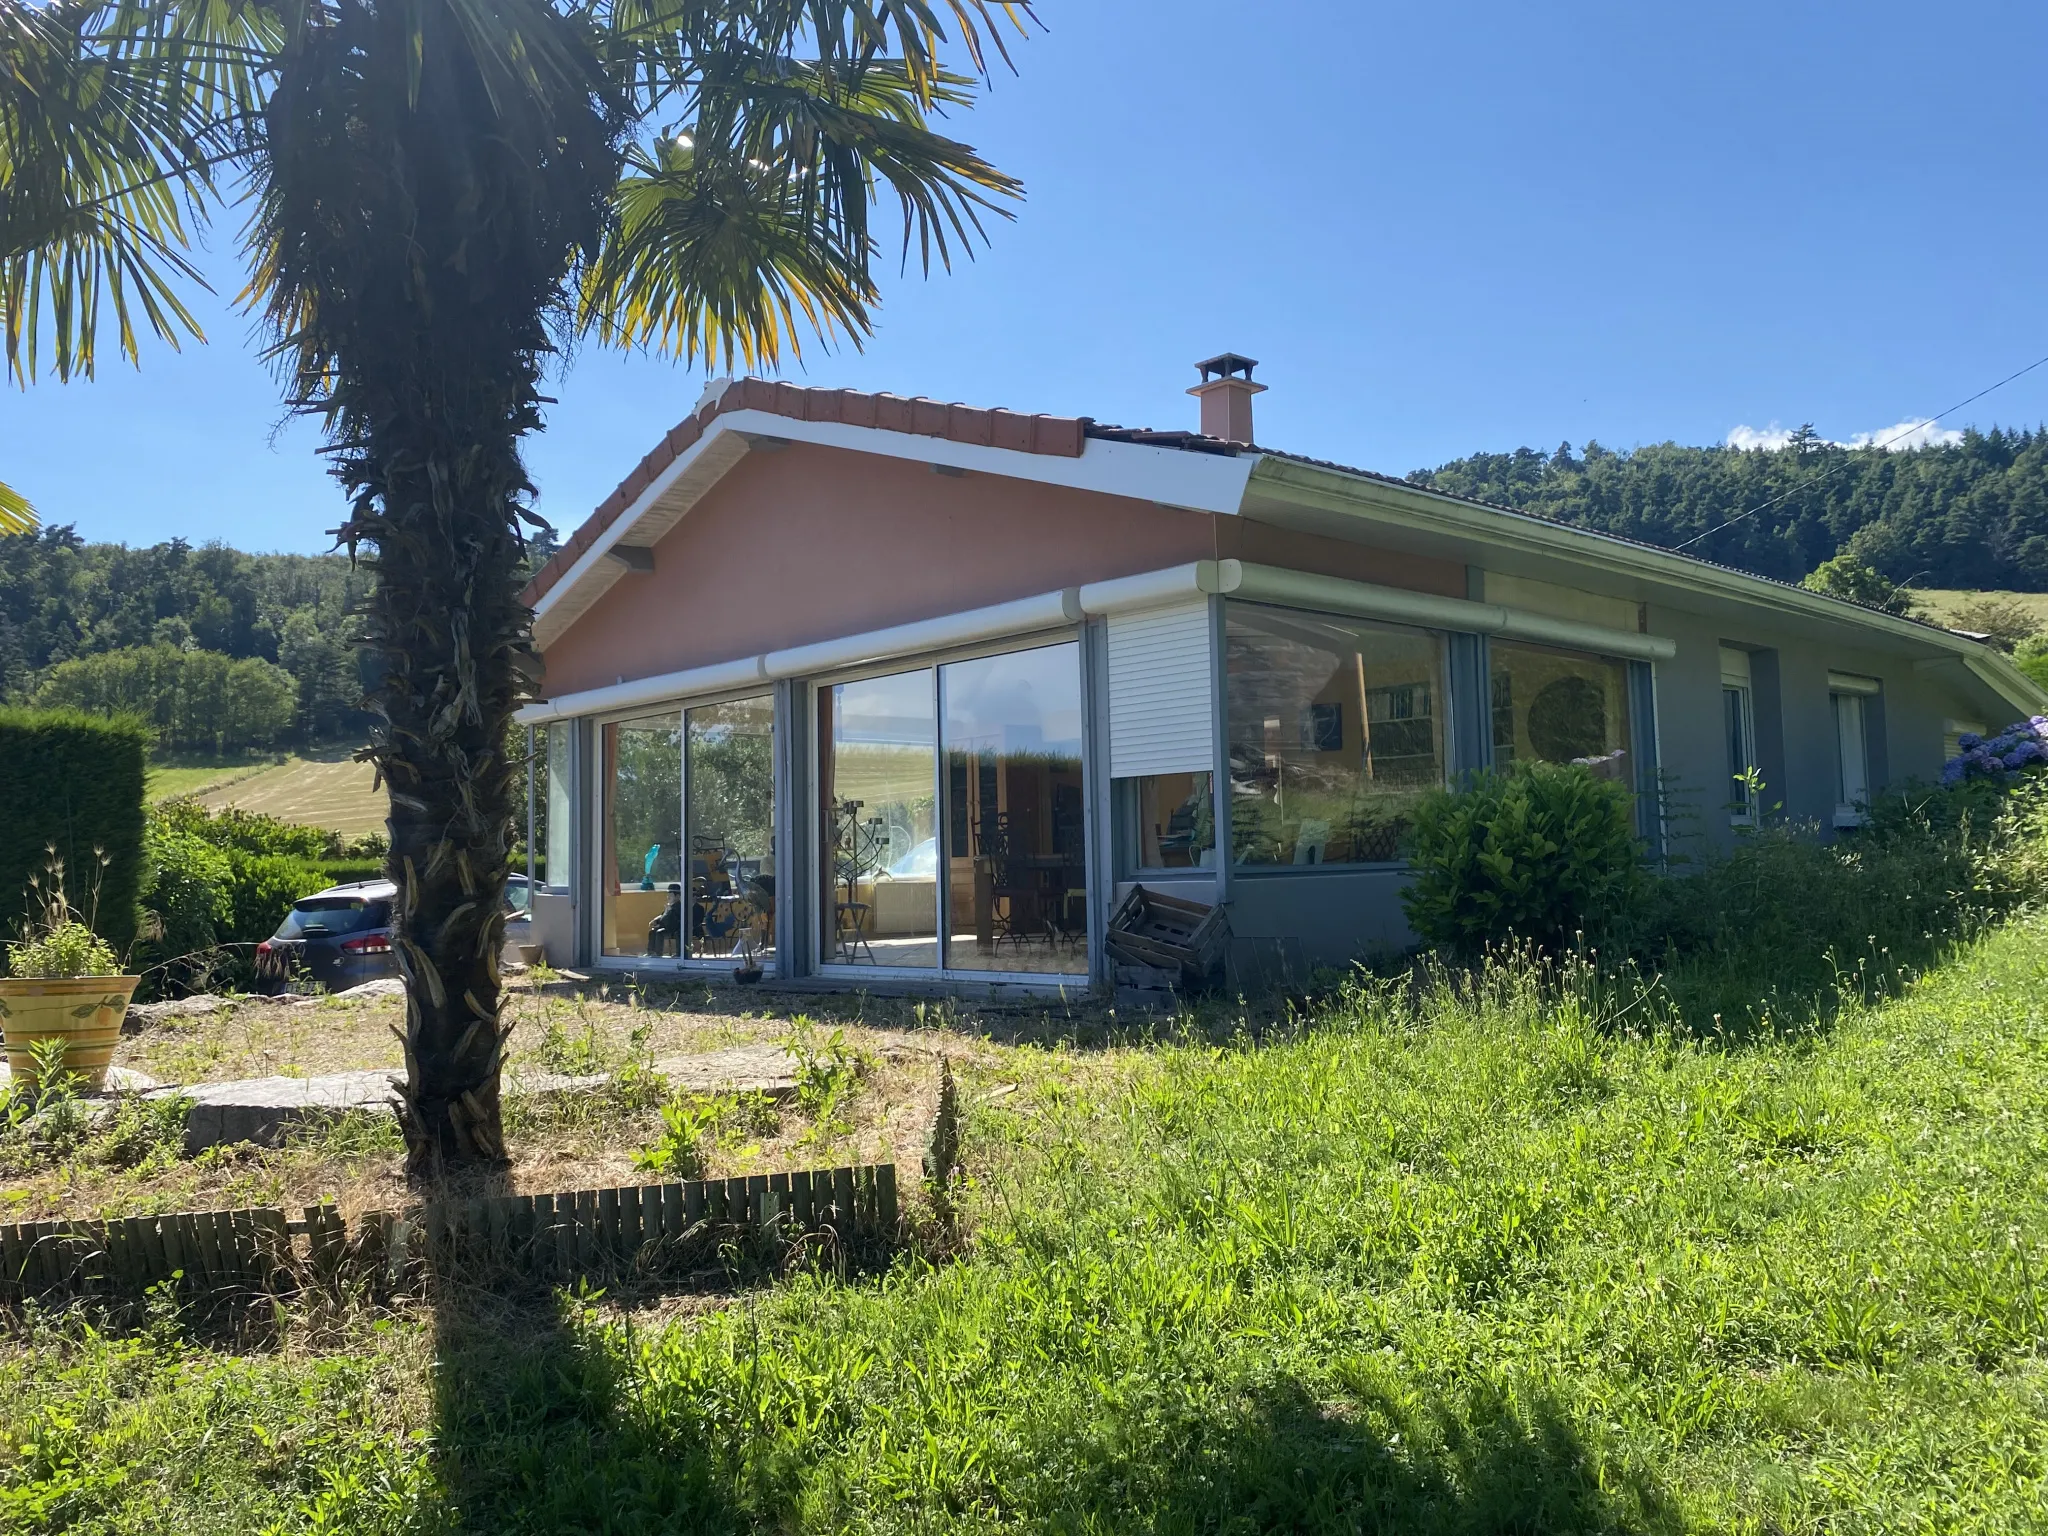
(0, 918), (2048, 1536)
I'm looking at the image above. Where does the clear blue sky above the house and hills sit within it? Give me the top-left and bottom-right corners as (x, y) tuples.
(0, 0), (2048, 551)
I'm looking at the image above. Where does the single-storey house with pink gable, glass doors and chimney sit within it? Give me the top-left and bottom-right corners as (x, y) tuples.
(520, 354), (2048, 987)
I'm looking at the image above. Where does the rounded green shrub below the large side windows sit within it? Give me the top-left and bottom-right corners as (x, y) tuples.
(1401, 762), (1640, 954)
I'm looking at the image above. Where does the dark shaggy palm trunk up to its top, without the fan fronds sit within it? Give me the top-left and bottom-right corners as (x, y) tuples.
(258, 0), (618, 1178)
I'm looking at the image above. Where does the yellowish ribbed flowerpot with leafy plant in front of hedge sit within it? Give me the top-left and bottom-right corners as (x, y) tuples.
(0, 860), (141, 1094)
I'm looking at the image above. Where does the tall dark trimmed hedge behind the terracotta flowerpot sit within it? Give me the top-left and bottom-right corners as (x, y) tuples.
(0, 709), (150, 952)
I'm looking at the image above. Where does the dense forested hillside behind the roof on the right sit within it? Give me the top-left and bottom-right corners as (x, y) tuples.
(1409, 428), (2048, 592)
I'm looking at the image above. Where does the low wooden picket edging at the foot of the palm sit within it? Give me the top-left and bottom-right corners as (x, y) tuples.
(0, 1163), (899, 1305)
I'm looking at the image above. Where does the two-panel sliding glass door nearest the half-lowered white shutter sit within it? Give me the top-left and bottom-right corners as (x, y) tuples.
(817, 641), (1087, 975)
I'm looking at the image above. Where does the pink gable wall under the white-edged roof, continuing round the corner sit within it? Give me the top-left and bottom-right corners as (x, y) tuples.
(547, 442), (1464, 694)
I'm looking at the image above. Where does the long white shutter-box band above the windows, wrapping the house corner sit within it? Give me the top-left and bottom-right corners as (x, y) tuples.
(512, 559), (1677, 725)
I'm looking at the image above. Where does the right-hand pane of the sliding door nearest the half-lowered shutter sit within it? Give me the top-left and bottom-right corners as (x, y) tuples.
(940, 643), (1087, 973)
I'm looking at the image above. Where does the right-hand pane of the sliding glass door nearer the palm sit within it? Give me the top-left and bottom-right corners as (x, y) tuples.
(686, 694), (776, 958)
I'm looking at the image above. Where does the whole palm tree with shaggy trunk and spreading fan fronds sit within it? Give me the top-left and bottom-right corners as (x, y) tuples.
(0, 0), (1028, 1176)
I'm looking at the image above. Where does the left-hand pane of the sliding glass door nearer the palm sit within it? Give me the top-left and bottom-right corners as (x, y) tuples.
(600, 711), (682, 954)
